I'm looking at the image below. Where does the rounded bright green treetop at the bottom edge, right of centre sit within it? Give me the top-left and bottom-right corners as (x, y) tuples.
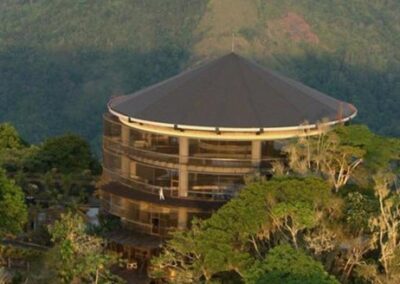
(248, 245), (339, 284)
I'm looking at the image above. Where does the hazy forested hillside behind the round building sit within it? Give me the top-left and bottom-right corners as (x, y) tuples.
(0, 0), (400, 152)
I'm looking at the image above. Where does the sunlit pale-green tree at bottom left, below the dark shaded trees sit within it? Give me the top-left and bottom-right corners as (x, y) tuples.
(47, 212), (120, 283)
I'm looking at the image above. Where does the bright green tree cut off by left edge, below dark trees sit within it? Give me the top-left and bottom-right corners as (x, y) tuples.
(0, 169), (28, 238)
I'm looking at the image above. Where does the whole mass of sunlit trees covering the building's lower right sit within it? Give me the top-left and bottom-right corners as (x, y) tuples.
(151, 125), (400, 284)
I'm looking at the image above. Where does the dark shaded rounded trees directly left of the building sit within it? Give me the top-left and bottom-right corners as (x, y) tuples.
(0, 124), (101, 207)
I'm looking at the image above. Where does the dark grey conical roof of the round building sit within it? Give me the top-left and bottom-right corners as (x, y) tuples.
(110, 53), (356, 128)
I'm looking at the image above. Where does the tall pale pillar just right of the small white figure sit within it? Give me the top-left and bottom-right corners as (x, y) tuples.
(178, 137), (189, 197)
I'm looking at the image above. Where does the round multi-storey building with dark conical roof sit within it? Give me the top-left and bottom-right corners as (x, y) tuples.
(101, 54), (357, 270)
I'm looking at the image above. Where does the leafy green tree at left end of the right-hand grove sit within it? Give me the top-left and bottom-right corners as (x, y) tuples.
(151, 183), (268, 283)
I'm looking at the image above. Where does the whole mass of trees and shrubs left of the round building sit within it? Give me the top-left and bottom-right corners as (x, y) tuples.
(0, 123), (124, 284)
